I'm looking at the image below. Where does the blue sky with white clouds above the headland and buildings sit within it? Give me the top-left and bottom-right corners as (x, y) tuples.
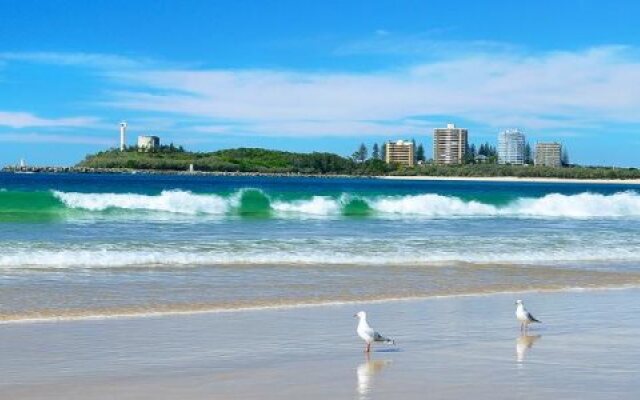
(0, 0), (640, 166)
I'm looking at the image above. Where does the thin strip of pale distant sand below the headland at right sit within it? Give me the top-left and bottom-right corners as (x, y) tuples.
(376, 175), (640, 185)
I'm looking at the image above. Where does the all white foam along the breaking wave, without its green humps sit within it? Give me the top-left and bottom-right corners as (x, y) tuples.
(53, 190), (640, 218)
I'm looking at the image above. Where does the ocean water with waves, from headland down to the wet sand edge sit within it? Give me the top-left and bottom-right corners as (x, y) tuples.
(0, 174), (640, 323)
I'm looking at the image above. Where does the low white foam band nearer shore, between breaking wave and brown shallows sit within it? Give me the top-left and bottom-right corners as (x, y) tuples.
(0, 246), (640, 269)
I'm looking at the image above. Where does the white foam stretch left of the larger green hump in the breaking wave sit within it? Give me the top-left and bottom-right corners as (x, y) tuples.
(53, 190), (230, 214)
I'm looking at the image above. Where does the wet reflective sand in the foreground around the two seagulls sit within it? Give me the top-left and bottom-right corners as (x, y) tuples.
(0, 289), (640, 400)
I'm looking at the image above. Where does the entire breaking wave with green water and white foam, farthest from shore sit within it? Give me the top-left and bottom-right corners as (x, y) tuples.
(0, 189), (640, 218)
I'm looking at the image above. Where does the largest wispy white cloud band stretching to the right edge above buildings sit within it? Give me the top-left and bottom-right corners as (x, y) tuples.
(102, 46), (640, 136)
